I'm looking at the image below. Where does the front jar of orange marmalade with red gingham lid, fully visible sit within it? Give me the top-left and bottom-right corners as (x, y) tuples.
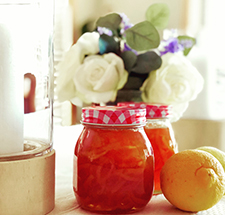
(73, 106), (154, 213)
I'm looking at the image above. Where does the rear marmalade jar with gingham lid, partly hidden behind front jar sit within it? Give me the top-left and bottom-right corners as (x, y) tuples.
(117, 102), (178, 194)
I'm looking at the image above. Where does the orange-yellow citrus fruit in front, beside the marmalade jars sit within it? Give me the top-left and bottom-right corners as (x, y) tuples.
(160, 150), (225, 212)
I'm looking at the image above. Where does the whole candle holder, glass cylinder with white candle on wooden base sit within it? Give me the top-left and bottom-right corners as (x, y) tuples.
(0, 0), (55, 215)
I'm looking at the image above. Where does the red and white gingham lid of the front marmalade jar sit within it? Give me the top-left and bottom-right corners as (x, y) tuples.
(82, 106), (146, 125)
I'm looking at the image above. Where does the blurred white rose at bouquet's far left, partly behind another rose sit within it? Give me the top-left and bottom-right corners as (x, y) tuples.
(56, 32), (99, 102)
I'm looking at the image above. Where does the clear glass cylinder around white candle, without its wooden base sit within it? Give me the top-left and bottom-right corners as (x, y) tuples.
(0, 0), (53, 160)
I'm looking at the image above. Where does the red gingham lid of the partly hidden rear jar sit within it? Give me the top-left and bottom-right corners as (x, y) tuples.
(117, 102), (172, 119)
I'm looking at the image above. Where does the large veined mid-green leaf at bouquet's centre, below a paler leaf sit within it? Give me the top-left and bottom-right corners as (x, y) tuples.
(125, 21), (160, 51)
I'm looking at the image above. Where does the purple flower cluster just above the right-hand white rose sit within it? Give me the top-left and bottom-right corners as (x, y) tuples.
(160, 38), (184, 56)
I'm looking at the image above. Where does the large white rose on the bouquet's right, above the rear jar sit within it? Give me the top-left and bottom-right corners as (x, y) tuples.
(141, 53), (204, 121)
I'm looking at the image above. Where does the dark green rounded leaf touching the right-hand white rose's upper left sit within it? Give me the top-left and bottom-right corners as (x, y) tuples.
(132, 51), (162, 74)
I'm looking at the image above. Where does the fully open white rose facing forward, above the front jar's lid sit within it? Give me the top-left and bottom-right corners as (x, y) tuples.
(73, 53), (128, 103)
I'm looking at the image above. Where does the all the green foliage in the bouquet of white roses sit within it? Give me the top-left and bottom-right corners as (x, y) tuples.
(93, 3), (196, 93)
